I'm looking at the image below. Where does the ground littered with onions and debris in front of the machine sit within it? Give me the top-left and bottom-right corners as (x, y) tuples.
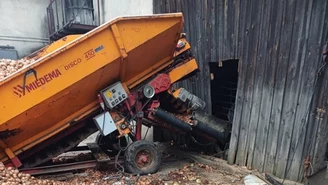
(0, 149), (258, 185)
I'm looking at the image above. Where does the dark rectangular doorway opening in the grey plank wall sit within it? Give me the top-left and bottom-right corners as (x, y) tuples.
(210, 60), (238, 122)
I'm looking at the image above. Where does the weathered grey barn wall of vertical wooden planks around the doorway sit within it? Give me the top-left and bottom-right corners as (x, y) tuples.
(153, 0), (328, 181)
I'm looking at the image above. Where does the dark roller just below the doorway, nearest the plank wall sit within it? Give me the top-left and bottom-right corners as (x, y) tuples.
(194, 121), (229, 141)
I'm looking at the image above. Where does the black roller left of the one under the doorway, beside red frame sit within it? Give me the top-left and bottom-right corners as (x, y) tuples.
(154, 109), (192, 132)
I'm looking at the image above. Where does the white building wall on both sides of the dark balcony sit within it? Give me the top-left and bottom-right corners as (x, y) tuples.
(0, 0), (153, 58)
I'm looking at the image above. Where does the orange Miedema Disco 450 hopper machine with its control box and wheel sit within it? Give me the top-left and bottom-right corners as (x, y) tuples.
(0, 13), (229, 174)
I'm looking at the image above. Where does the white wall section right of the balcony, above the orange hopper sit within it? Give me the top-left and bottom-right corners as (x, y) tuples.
(100, 0), (153, 23)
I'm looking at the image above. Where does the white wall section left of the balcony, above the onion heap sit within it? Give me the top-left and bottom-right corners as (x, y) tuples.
(0, 0), (50, 57)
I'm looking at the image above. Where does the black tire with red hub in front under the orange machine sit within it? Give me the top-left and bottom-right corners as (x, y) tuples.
(125, 140), (161, 175)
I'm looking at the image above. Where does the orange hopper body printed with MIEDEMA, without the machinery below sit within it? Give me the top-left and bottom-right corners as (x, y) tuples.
(0, 13), (197, 162)
